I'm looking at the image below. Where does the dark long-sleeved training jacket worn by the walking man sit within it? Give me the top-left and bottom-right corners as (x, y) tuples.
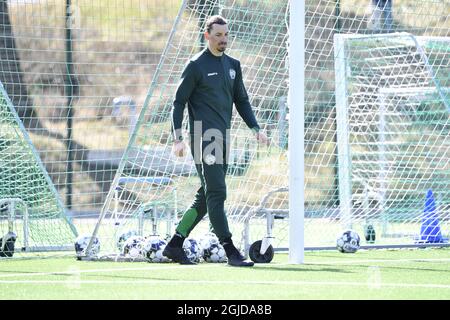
(172, 48), (259, 139)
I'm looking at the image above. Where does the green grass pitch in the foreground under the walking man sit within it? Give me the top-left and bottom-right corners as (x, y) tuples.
(0, 247), (450, 300)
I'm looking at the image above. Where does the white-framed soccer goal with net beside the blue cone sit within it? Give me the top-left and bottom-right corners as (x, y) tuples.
(334, 33), (450, 245)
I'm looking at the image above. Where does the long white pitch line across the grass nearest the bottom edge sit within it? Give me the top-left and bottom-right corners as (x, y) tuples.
(0, 280), (450, 290)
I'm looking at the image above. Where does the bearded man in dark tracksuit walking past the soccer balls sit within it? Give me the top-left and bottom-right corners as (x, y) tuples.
(163, 16), (268, 266)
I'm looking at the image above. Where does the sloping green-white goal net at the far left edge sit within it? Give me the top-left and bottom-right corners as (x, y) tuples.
(0, 83), (77, 252)
